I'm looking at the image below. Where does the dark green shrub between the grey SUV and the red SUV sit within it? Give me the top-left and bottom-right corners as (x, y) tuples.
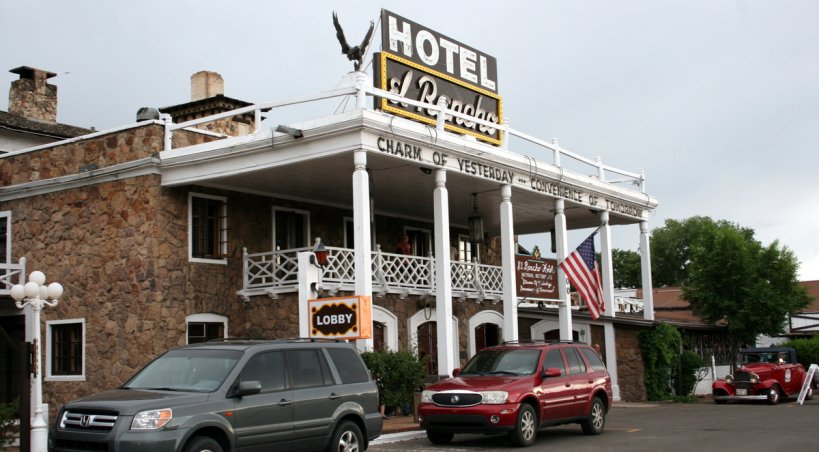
(361, 351), (426, 407)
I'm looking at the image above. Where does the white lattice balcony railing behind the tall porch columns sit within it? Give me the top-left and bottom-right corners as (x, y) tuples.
(239, 246), (503, 302)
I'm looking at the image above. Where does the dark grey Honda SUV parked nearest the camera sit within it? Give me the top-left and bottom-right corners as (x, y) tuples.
(49, 339), (383, 452)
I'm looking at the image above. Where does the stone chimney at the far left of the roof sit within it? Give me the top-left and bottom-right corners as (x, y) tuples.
(9, 66), (57, 123)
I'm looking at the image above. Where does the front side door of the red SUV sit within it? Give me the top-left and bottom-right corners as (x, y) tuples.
(538, 348), (574, 423)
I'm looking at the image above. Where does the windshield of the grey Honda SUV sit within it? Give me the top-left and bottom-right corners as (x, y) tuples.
(121, 349), (242, 392)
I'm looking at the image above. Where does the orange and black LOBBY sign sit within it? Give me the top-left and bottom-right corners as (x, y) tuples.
(307, 296), (373, 339)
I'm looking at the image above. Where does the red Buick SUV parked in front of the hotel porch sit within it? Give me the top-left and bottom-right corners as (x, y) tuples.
(419, 341), (612, 446)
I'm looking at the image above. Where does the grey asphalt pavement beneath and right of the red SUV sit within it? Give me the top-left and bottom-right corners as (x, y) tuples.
(368, 397), (819, 452)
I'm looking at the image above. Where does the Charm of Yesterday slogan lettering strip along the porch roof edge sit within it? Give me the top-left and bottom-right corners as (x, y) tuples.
(374, 137), (645, 219)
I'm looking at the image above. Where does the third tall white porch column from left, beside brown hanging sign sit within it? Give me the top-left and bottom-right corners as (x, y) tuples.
(500, 184), (518, 341)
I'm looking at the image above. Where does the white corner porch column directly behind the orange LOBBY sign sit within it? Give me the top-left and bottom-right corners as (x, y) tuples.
(353, 150), (373, 351)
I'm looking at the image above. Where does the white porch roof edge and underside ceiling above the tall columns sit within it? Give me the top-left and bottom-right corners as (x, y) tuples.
(163, 112), (652, 235)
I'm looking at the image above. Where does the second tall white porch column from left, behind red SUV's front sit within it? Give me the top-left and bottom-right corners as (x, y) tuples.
(433, 169), (456, 376)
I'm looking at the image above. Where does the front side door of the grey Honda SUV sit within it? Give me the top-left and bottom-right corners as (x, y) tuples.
(234, 351), (294, 452)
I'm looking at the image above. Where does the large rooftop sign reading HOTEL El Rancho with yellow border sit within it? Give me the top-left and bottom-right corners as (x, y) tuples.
(373, 9), (503, 144)
